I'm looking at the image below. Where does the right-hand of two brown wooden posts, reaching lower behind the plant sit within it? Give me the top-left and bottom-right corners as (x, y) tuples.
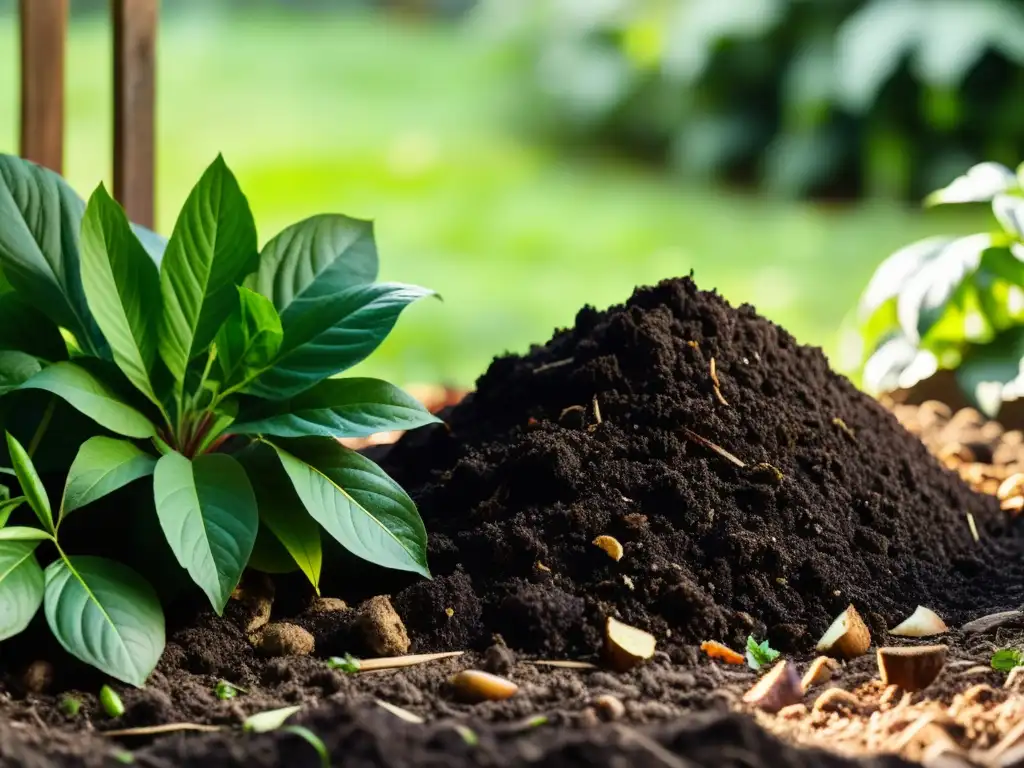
(113, 0), (160, 227)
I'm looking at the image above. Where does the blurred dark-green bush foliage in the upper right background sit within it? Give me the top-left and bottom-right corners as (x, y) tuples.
(480, 0), (1024, 197)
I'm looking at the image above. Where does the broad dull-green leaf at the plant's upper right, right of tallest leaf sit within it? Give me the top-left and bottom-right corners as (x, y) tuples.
(246, 214), (378, 312)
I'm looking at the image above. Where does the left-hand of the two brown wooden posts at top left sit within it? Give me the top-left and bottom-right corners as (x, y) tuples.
(19, 0), (68, 173)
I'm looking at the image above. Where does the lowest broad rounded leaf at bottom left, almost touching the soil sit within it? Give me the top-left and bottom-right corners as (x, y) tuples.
(44, 555), (165, 687)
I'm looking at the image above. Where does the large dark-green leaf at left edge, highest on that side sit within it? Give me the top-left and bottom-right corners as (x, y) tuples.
(0, 155), (105, 354)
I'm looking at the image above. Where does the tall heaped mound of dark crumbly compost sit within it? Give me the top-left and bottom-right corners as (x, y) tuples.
(385, 279), (1020, 660)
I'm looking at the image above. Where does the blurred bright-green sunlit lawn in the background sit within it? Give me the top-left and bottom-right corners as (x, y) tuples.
(0, 0), (977, 391)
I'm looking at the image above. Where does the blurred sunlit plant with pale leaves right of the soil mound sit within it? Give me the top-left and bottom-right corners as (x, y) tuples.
(857, 163), (1024, 416)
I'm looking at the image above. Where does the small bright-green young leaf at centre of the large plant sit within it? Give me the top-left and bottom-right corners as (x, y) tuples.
(216, 287), (284, 386)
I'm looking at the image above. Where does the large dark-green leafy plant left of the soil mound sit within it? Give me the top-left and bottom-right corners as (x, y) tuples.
(0, 156), (437, 685)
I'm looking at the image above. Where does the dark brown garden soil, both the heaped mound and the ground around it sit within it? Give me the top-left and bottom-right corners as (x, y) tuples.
(0, 279), (1024, 768)
